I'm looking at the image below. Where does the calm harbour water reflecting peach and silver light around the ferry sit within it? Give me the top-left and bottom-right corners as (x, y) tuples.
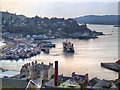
(0, 25), (118, 80)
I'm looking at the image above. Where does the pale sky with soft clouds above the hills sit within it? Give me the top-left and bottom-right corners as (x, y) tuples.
(0, 0), (119, 18)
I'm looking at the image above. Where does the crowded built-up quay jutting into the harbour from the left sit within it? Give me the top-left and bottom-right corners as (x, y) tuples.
(0, 39), (55, 60)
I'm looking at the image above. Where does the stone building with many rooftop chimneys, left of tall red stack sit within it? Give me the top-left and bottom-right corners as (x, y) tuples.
(20, 61), (54, 80)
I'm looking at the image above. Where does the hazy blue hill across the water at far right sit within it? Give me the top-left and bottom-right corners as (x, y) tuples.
(73, 15), (120, 25)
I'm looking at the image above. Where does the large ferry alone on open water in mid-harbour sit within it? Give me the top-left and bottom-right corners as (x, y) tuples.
(63, 41), (75, 53)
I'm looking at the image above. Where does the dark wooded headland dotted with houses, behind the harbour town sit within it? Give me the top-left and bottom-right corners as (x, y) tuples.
(2, 12), (103, 38)
